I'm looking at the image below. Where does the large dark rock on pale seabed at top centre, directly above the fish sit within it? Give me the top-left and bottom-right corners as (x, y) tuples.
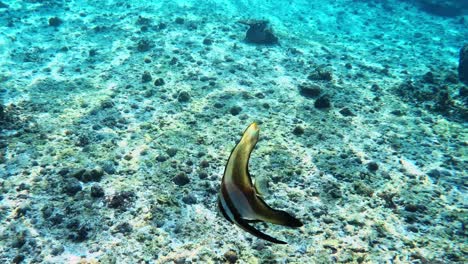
(239, 20), (278, 45)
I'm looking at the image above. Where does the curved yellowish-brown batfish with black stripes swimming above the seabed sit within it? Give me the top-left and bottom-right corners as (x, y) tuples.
(218, 123), (303, 244)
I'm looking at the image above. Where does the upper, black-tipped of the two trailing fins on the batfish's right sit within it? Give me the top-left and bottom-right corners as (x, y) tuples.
(255, 197), (304, 227)
